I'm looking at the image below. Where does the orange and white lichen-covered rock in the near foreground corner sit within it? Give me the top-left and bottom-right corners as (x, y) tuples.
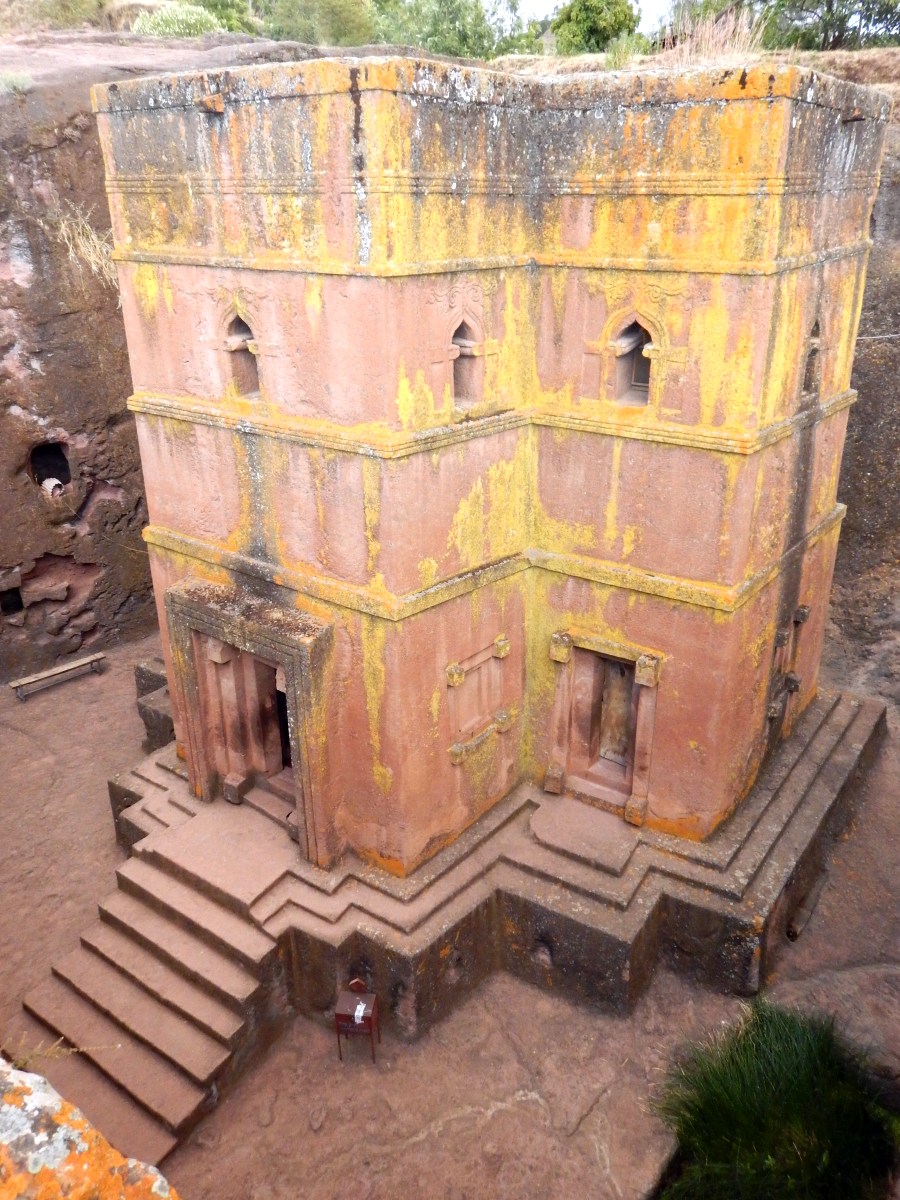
(0, 1061), (178, 1200)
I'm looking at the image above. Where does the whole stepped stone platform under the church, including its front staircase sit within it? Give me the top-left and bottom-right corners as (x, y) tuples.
(6, 695), (884, 1163)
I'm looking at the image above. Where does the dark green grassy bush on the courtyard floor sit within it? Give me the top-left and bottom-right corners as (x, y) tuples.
(656, 1001), (898, 1200)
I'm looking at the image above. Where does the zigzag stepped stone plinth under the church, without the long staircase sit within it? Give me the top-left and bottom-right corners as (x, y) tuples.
(113, 695), (884, 1037)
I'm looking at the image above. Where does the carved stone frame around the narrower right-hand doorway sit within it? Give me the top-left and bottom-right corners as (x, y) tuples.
(545, 629), (664, 824)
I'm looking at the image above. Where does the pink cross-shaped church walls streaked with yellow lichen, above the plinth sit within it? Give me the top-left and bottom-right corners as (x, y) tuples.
(88, 58), (888, 874)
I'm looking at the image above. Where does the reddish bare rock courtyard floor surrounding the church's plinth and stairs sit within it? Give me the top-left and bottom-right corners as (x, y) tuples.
(0, 619), (900, 1200)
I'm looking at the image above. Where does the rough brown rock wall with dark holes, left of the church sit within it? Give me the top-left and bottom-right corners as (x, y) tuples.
(0, 70), (152, 678)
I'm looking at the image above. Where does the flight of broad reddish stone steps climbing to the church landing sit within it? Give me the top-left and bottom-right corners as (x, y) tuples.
(5, 839), (286, 1163)
